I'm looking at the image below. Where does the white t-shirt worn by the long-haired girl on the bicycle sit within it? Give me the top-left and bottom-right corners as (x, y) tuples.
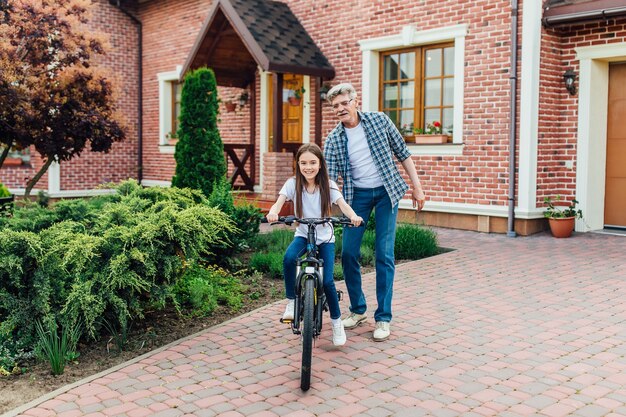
(279, 178), (343, 245)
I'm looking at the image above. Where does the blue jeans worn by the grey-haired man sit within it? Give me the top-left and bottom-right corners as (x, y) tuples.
(341, 187), (398, 322)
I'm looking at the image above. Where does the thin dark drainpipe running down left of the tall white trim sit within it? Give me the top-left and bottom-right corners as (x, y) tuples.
(506, 0), (518, 237)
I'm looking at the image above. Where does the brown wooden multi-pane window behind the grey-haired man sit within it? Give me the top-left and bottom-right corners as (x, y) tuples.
(379, 43), (455, 134)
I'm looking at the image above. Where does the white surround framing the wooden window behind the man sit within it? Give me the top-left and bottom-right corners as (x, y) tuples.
(358, 24), (467, 155)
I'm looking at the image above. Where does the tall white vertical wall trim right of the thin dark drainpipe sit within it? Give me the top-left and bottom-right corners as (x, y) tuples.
(515, 1), (542, 217)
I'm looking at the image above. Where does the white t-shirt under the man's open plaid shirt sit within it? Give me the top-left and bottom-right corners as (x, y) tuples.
(345, 122), (383, 188)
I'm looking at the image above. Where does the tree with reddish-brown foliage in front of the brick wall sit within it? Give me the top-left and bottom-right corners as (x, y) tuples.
(0, 0), (125, 196)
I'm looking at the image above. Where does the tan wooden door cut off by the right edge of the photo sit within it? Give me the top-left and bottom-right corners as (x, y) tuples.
(604, 63), (626, 228)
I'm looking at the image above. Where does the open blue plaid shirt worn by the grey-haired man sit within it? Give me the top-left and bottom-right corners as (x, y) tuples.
(324, 112), (411, 206)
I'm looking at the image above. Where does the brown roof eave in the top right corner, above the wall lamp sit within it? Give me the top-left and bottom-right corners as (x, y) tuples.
(543, 0), (626, 26)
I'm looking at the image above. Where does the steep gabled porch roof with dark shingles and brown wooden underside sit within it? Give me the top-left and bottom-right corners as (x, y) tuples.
(183, 0), (335, 87)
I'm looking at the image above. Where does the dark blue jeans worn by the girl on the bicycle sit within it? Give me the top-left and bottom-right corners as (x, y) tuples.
(283, 236), (341, 319)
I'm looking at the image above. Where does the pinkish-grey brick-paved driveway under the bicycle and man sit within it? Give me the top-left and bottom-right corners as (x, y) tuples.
(7, 229), (626, 417)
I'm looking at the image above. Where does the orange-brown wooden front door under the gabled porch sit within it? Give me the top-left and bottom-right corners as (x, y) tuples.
(268, 74), (304, 153)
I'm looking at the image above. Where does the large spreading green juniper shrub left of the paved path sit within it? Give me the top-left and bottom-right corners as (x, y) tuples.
(0, 177), (235, 355)
